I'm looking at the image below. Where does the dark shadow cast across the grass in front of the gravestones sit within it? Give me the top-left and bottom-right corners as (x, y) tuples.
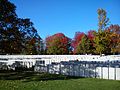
(0, 71), (84, 82)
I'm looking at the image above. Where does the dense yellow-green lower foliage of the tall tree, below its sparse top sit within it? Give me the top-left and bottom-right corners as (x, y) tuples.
(94, 31), (110, 55)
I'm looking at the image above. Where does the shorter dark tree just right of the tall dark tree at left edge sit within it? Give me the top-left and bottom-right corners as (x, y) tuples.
(18, 18), (41, 54)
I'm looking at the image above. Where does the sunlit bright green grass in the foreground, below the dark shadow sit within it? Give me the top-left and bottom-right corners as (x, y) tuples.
(0, 71), (120, 90)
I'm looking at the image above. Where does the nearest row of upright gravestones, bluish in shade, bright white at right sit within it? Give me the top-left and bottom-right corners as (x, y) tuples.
(42, 61), (120, 80)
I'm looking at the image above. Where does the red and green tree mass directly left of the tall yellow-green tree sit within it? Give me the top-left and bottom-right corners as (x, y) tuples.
(72, 30), (94, 54)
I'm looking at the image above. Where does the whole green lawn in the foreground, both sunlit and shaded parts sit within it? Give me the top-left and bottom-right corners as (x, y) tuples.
(0, 72), (120, 90)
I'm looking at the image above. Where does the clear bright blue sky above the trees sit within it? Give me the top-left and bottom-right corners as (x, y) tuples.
(10, 0), (120, 39)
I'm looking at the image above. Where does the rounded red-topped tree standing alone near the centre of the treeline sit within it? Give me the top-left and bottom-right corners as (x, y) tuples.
(46, 33), (71, 55)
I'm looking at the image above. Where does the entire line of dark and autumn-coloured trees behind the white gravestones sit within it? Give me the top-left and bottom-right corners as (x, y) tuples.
(0, 0), (120, 55)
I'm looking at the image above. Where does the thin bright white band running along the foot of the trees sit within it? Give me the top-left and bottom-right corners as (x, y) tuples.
(0, 55), (120, 62)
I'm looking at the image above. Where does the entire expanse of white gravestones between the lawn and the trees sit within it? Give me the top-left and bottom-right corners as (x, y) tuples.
(0, 55), (120, 80)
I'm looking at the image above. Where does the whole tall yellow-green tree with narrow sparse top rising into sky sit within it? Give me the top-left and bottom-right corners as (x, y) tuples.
(94, 9), (110, 55)
